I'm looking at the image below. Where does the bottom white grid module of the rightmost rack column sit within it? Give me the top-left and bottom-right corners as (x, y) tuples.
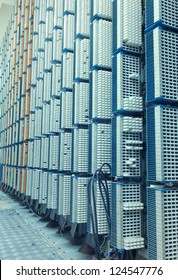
(147, 185), (178, 260)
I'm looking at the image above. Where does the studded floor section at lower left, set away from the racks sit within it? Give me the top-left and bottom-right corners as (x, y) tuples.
(0, 210), (62, 260)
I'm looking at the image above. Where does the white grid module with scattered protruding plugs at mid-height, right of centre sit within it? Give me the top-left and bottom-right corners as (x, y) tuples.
(112, 116), (143, 177)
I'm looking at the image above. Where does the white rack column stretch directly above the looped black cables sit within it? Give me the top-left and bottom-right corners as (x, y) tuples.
(89, 0), (112, 173)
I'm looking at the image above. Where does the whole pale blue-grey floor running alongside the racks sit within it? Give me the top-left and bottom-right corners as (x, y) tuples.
(0, 191), (91, 260)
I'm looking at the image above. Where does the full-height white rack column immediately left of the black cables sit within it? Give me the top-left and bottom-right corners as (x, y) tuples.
(70, 0), (90, 235)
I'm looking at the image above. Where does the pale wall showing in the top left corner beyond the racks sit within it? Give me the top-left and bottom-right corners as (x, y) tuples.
(0, 1), (14, 43)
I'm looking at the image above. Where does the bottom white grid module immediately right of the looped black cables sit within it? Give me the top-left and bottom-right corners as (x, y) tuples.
(111, 183), (144, 250)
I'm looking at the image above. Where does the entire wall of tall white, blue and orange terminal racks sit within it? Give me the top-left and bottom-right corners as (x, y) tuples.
(0, 0), (178, 259)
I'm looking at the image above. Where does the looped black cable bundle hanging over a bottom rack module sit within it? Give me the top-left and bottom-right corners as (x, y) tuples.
(88, 163), (111, 259)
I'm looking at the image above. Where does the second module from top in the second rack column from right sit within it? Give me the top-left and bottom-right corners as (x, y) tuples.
(112, 53), (143, 111)
